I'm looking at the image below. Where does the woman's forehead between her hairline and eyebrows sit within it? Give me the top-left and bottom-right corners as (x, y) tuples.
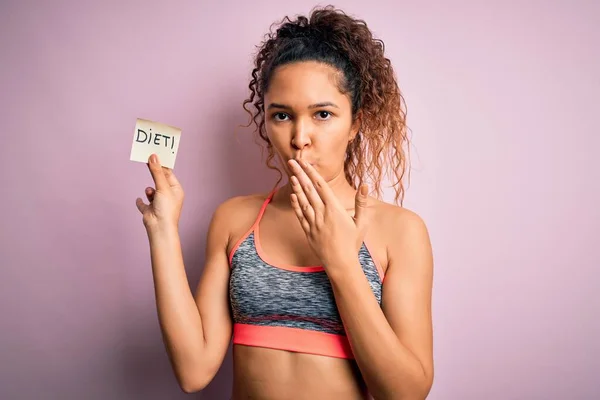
(265, 61), (349, 107)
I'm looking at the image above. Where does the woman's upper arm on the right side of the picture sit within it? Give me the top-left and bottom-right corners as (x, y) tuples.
(382, 209), (433, 386)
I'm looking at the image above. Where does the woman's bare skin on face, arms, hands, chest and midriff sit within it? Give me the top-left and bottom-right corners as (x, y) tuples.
(137, 62), (433, 399)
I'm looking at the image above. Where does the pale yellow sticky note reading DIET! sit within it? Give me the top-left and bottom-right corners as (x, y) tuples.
(129, 118), (181, 168)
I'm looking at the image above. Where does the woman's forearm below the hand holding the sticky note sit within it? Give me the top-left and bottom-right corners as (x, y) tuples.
(148, 227), (205, 385)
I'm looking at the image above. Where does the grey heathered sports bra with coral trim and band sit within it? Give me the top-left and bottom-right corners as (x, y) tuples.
(229, 189), (384, 359)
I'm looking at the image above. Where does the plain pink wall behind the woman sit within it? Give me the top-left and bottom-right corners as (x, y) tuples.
(0, 0), (600, 400)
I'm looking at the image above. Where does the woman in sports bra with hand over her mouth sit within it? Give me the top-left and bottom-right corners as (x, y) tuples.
(137, 7), (433, 399)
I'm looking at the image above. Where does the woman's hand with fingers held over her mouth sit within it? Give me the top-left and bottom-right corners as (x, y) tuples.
(289, 160), (369, 269)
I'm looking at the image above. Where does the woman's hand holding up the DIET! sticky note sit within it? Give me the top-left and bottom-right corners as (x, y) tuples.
(135, 154), (184, 230)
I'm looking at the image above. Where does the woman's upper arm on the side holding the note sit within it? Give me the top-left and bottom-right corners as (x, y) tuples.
(194, 199), (239, 379)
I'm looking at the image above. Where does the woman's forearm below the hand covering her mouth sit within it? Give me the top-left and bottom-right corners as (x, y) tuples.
(328, 260), (429, 400)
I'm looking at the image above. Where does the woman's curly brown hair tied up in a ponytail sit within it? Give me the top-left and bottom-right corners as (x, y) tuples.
(243, 6), (409, 204)
